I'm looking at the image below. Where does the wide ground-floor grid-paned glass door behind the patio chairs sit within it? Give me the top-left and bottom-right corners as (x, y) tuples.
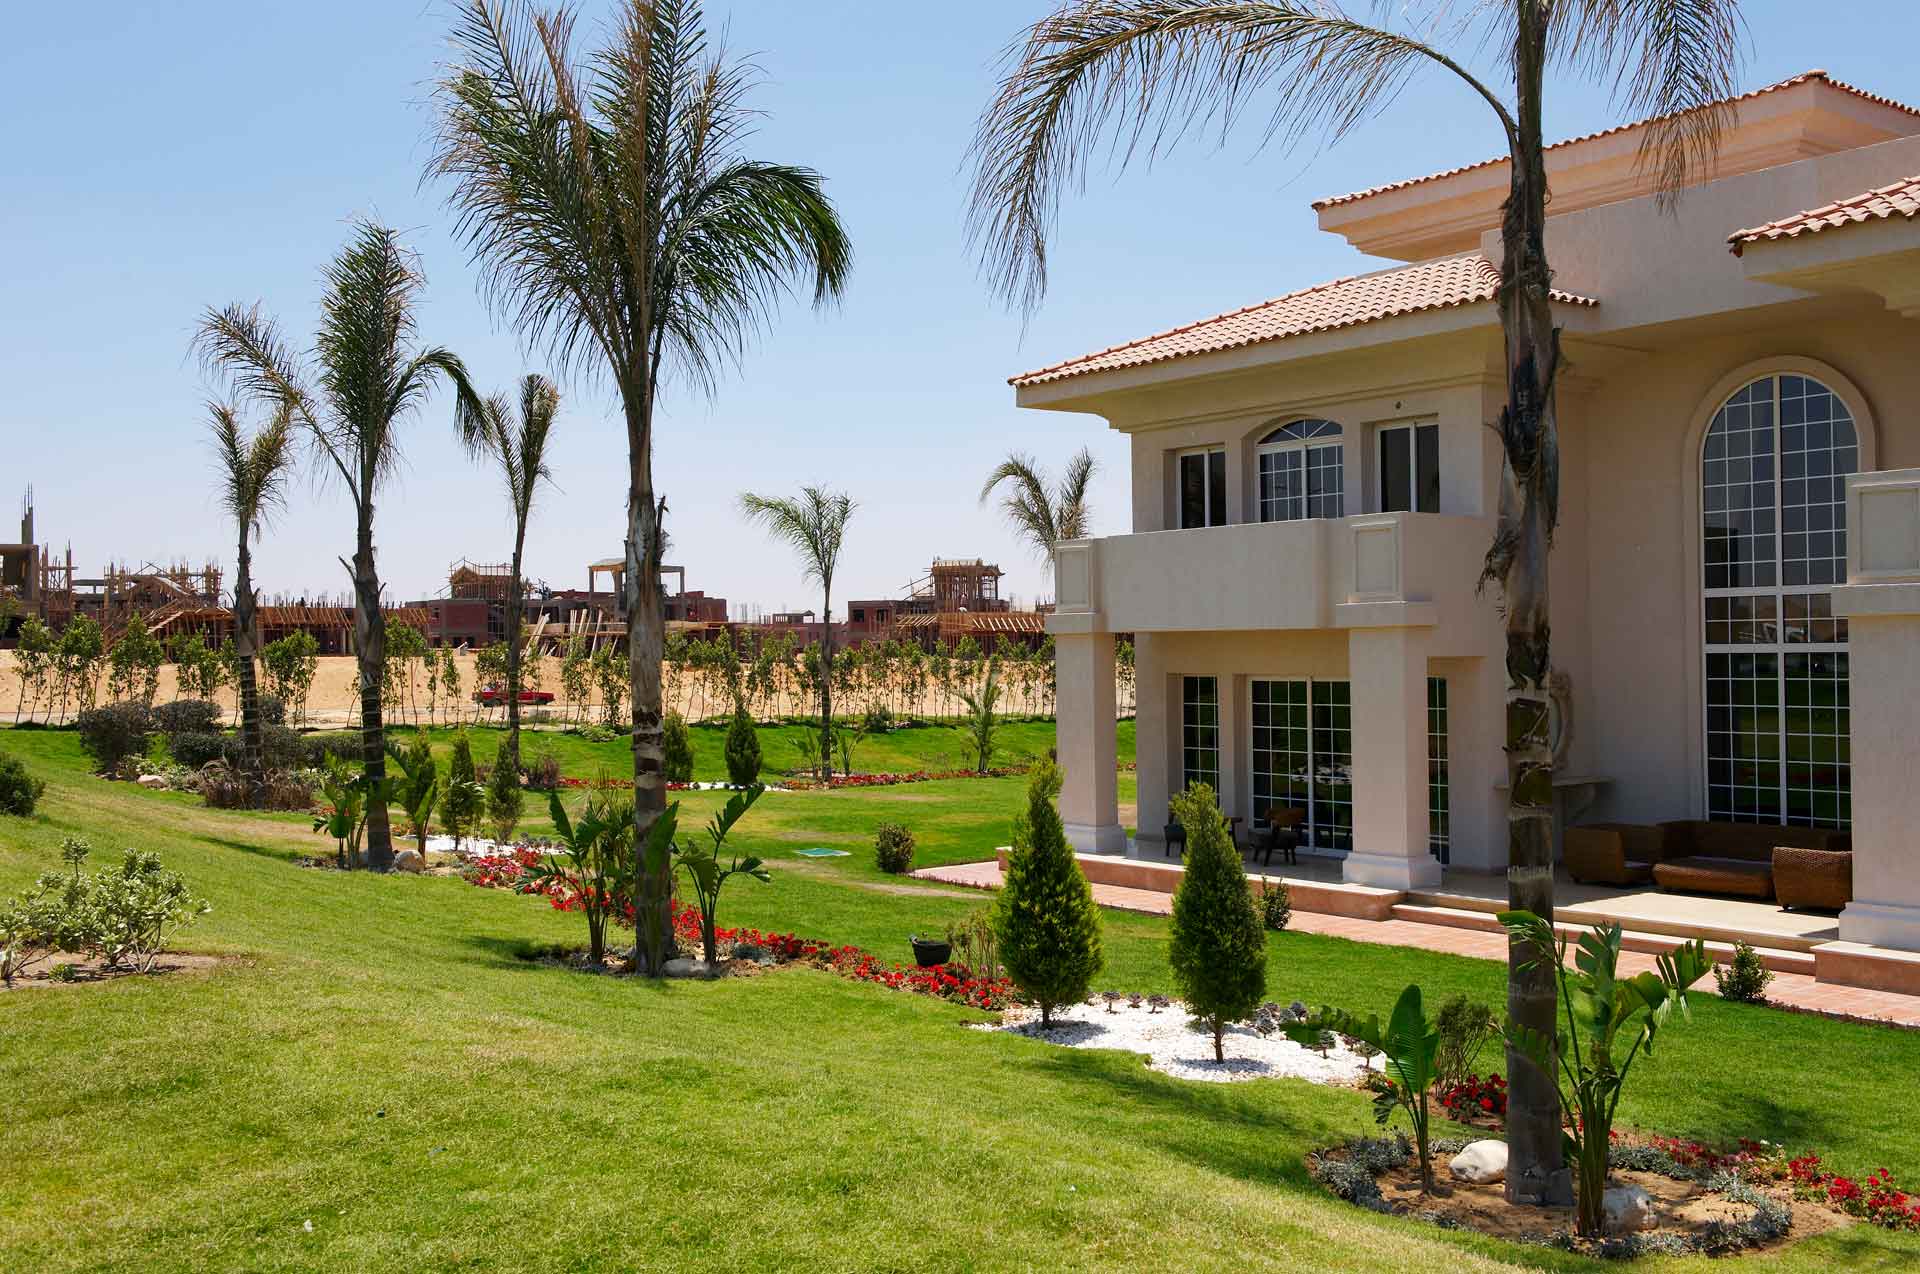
(1250, 679), (1354, 850)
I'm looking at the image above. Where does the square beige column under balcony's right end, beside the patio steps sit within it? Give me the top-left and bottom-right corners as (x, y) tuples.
(1342, 627), (1440, 888)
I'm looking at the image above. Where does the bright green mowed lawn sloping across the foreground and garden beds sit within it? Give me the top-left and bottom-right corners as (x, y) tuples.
(0, 731), (1920, 1272)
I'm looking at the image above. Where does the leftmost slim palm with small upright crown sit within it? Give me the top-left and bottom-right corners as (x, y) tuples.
(207, 403), (294, 792)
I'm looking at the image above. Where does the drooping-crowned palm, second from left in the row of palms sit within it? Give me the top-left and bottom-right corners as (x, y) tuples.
(196, 221), (482, 871)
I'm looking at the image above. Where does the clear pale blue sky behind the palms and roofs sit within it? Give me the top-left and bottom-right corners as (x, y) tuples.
(0, 0), (1920, 608)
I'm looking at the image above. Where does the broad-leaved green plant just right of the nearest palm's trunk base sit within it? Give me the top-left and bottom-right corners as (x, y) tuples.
(1500, 911), (1713, 1236)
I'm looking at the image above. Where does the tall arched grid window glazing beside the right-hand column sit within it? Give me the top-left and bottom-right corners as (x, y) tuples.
(1701, 374), (1860, 827)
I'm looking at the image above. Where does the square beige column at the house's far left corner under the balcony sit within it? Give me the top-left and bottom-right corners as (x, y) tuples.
(1054, 633), (1127, 854)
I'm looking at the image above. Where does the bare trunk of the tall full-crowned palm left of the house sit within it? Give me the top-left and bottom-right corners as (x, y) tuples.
(620, 399), (672, 977)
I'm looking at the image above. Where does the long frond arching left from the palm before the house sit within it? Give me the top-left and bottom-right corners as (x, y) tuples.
(968, 0), (1513, 311)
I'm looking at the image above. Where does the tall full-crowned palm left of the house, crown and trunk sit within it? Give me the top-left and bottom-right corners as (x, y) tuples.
(432, 0), (852, 975)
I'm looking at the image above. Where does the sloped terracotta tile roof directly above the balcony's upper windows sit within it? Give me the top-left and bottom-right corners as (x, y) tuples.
(1010, 253), (1599, 386)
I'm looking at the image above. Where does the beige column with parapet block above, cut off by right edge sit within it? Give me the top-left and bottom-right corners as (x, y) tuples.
(1834, 468), (1920, 952)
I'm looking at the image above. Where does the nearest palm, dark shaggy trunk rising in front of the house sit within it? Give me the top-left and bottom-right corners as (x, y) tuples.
(970, 0), (1741, 1201)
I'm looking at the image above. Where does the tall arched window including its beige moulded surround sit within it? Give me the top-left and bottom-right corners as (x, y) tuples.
(1690, 359), (1874, 827)
